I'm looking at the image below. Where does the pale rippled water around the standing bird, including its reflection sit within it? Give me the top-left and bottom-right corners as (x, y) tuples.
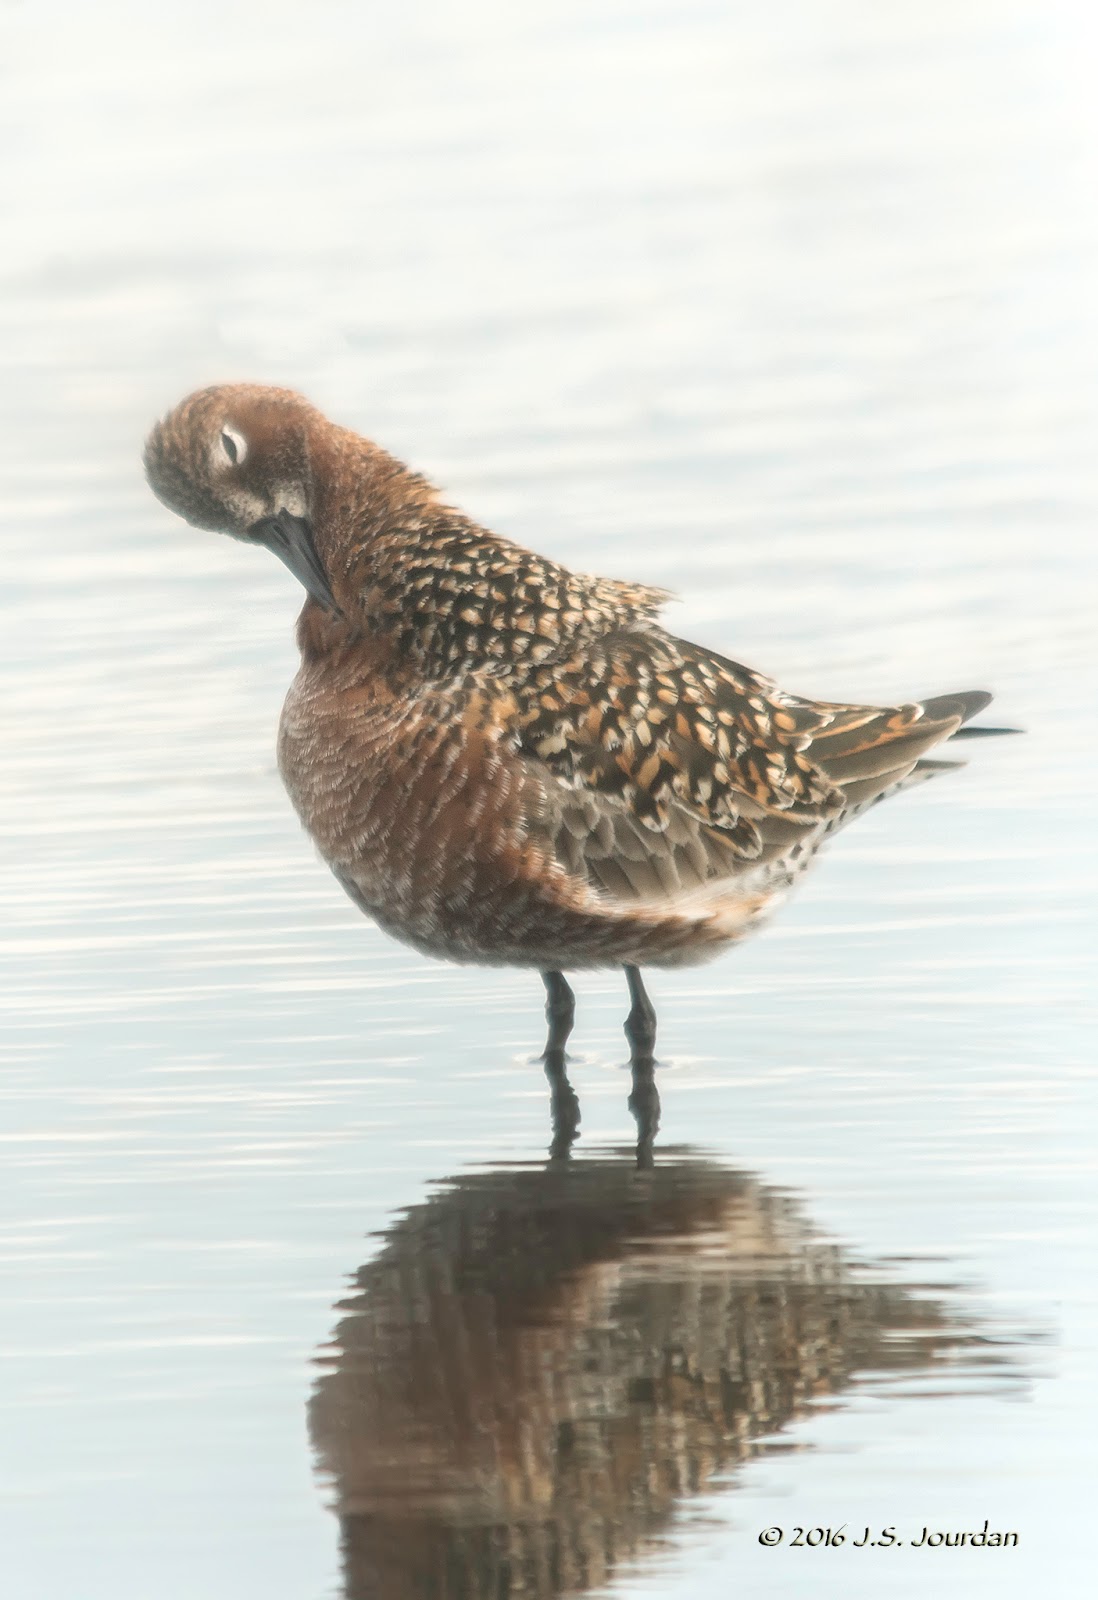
(0, 0), (1098, 1600)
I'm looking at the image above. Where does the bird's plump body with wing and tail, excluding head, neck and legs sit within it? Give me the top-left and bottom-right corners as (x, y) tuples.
(282, 507), (989, 966)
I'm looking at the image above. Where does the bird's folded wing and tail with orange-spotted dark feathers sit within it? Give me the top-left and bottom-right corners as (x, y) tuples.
(507, 629), (986, 899)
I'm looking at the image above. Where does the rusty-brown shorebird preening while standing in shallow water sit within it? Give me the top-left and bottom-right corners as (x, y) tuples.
(144, 384), (1010, 1115)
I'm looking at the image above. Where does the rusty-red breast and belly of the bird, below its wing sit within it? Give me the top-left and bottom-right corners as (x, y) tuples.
(279, 669), (832, 968)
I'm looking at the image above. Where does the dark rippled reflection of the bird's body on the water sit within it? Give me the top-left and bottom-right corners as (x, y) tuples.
(311, 1150), (1007, 1600)
